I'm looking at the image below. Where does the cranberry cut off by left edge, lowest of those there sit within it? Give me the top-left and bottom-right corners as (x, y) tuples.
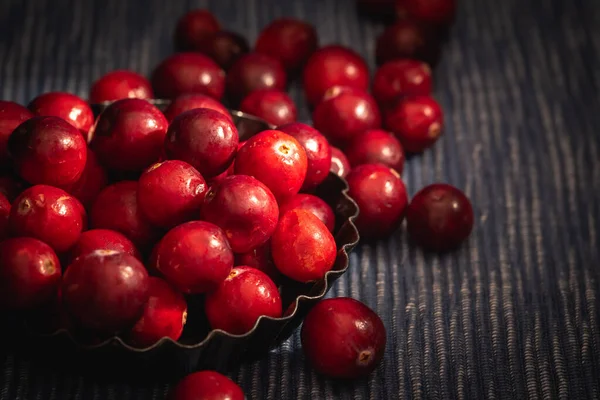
(0, 237), (61, 309)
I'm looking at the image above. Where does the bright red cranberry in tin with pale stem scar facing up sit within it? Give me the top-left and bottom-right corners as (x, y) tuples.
(235, 130), (308, 201)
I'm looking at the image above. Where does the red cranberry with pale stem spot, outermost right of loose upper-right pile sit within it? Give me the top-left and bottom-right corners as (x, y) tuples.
(385, 96), (444, 153)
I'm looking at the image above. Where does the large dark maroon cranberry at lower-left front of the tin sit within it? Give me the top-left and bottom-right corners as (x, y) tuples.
(61, 250), (150, 334)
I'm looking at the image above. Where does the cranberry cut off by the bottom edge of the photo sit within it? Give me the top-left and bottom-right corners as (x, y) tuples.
(169, 371), (245, 400)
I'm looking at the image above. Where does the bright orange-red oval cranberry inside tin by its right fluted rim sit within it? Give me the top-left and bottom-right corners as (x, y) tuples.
(271, 209), (337, 282)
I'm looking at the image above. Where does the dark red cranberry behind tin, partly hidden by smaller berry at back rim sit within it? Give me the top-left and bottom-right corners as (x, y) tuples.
(227, 53), (287, 103)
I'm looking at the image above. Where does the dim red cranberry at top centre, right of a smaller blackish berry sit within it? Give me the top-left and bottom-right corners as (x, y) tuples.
(255, 18), (319, 72)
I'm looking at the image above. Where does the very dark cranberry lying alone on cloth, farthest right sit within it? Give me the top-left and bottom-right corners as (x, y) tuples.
(406, 183), (474, 252)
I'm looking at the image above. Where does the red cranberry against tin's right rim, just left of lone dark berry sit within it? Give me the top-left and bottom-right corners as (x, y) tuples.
(346, 164), (408, 239)
